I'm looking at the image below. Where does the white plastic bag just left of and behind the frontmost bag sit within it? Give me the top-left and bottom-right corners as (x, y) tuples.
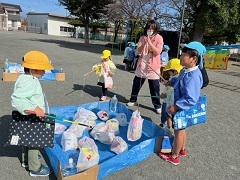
(61, 130), (78, 151)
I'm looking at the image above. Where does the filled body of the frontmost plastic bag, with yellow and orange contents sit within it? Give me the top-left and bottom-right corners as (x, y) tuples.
(77, 147), (99, 172)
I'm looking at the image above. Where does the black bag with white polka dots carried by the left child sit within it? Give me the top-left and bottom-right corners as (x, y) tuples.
(5, 111), (55, 148)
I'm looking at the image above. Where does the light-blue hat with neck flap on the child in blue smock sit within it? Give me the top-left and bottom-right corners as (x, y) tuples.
(185, 41), (207, 69)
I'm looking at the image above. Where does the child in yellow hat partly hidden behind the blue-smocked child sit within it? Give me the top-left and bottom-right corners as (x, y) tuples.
(160, 58), (182, 130)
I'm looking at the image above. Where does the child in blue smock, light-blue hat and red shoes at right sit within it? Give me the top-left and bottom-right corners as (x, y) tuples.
(159, 41), (206, 165)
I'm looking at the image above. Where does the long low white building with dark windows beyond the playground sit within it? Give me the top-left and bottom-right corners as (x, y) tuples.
(27, 12), (74, 36)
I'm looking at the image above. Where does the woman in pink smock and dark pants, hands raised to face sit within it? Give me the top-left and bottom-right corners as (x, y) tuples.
(127, 20), (163, 114)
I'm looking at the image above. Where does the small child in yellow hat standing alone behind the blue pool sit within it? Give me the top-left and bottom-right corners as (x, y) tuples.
(92, 50), (116, 101)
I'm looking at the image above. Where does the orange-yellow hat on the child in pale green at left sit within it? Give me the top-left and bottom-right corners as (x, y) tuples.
(22, 51), (53, 70)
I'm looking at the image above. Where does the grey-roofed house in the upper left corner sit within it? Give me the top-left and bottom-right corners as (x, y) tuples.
(0, 2), (22, 31)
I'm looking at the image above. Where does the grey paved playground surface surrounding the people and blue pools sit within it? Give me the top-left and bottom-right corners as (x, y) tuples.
(0, 31), (240, 180)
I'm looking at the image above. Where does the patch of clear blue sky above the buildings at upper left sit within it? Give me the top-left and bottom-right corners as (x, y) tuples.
(0, 0), (69, 18)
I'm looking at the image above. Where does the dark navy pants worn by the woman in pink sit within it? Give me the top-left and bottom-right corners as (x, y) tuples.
(130, 76), (161, 109)
